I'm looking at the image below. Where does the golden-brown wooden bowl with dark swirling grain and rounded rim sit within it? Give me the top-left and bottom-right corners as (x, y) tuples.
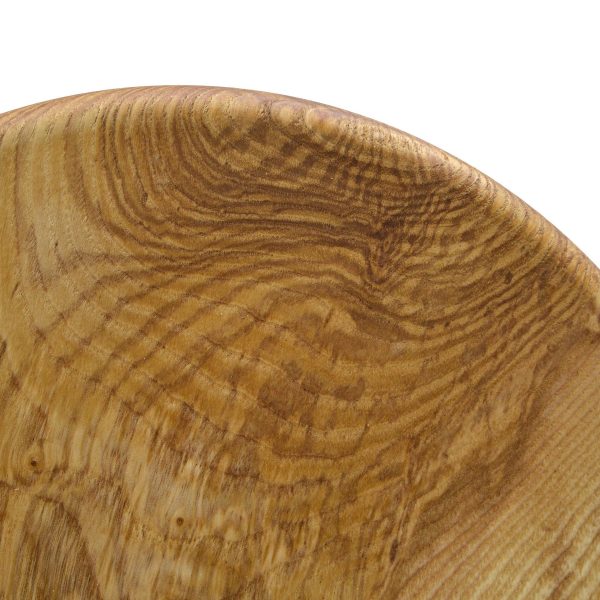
(0, 87), (600, 600)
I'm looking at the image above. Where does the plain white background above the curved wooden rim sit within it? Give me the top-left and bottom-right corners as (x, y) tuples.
(0, 0), (600, 265)
